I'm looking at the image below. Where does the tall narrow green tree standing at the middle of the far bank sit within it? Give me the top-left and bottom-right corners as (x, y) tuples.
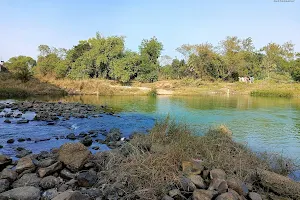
(137, 37), (163, 82)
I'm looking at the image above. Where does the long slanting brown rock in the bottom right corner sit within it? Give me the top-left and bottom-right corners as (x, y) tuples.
(257, 170), (300, 199)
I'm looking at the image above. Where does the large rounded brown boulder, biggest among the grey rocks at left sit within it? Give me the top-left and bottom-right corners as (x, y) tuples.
(58, 143), (91, 171)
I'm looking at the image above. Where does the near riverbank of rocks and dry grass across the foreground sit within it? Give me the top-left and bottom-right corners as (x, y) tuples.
(0, 113), (300, 200)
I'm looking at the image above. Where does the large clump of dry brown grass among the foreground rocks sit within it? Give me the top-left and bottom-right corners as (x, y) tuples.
(92, 119), (296, 199)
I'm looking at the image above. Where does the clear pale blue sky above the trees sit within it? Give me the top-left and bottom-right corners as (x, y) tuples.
(0, 0), (300, 60)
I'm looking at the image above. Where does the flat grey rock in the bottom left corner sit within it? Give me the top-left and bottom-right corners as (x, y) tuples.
(0, 186), (41, 200)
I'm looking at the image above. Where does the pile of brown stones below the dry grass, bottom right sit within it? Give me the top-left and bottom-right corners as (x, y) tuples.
(163, 160), (300, 200)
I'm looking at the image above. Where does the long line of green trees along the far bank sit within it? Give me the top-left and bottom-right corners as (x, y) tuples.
(6, 33), (300, 83)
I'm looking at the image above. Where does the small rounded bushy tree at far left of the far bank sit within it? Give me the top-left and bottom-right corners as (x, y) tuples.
(7, 56), (36, 82)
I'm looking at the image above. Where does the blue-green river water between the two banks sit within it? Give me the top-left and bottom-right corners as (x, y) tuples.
(0, 96), (300, 180)
